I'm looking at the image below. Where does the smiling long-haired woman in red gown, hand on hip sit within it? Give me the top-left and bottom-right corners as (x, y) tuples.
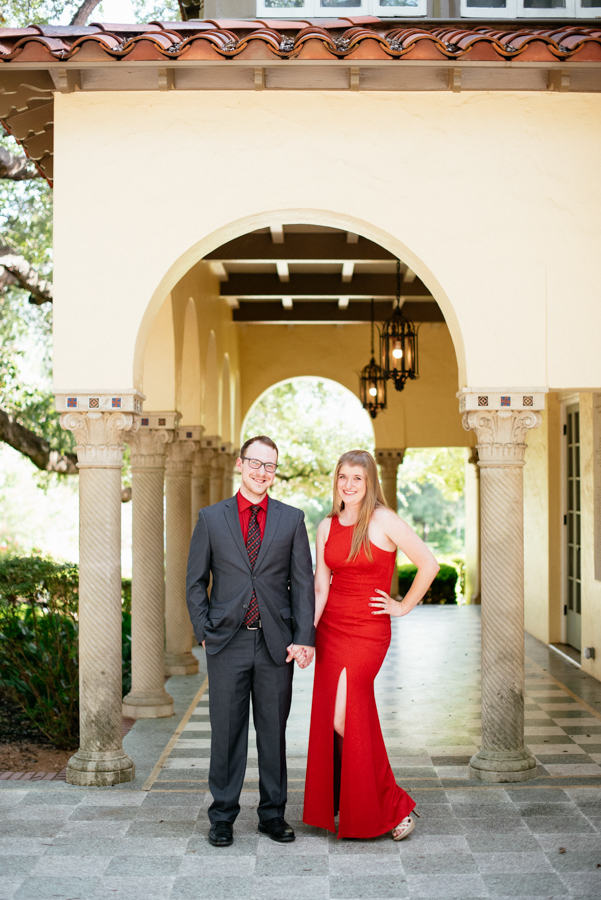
(303, 450), (438, 841)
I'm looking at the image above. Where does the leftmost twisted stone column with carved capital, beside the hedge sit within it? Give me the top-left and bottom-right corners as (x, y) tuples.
(61, 411), (139, 787)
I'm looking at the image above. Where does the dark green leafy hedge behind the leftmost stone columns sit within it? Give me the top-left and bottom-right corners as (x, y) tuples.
(0, 555), (131, 749)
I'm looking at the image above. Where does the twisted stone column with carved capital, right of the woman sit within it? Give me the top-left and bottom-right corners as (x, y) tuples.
(463, 410), (541, 782)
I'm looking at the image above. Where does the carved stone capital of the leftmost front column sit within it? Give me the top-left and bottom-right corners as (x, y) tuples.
(60, 409), (140, 469)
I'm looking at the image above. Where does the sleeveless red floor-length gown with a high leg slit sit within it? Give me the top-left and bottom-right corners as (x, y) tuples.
(303, 516), (415, 838)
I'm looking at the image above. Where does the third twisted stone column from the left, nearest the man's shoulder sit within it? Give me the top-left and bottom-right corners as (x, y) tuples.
(165, 441), (198, 675)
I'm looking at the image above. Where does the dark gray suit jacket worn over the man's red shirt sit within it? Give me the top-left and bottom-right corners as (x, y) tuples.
(186, 497), (315, 665)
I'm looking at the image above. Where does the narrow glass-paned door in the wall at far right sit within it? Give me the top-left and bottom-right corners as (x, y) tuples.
(566, 403), (582, 650)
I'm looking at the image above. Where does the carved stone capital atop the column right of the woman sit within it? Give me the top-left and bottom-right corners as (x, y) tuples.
(462, 409), (542, 467)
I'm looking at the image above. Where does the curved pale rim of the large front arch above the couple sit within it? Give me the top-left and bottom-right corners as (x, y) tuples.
(133, 209), (466, 396)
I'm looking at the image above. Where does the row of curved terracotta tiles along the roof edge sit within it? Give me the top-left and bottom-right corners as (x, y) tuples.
(0, 16), (601, 63)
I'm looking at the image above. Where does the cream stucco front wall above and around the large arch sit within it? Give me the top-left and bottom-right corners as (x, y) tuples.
(54, 91), (601, 389)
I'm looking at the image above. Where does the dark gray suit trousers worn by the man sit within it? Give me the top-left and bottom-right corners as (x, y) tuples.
(207, 627), (294, 823)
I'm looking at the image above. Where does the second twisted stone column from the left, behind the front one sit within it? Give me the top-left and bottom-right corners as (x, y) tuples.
(123, 429), (173, 719)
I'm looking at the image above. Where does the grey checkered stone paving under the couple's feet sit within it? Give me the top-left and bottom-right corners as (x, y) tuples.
(0, 607), (601, 900)
